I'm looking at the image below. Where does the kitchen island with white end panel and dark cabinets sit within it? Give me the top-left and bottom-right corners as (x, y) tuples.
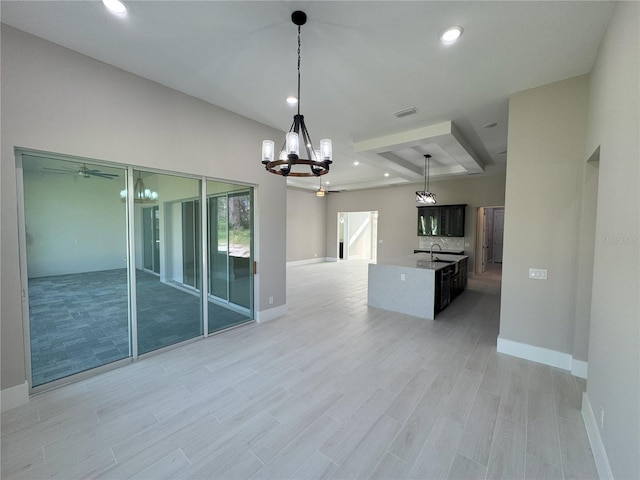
(367, 252), (468, 320)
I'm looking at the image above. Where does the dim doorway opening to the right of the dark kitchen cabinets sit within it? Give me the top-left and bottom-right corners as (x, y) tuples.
(475, 206), (504, 273)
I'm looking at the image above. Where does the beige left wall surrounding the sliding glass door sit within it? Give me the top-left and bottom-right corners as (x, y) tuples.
(0, 25), (286, 389)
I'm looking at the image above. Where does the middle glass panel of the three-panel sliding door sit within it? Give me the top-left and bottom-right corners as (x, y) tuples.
(134, 171), (203, 354)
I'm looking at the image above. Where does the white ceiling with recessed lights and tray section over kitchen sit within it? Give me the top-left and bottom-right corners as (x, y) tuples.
(0, 0), (614, 190)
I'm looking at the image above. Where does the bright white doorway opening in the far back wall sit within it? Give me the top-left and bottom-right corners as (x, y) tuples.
(338, 211), (378, 262)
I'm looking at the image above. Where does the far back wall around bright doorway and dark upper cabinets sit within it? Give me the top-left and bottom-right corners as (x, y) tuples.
(326, 176), (505, 265)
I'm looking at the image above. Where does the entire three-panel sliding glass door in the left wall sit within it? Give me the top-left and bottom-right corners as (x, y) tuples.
(18, 152), (253, 387)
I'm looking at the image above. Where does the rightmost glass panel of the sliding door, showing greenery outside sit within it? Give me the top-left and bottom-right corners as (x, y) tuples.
(207, 181), (253, 332)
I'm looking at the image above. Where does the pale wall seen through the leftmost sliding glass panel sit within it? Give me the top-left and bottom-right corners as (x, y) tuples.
(24, 166), (127, 278)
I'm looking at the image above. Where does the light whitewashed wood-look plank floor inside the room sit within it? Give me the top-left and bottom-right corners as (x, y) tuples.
(2, 261), (597, 480)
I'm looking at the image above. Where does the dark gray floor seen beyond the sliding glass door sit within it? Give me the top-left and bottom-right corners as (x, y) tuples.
(29, 269), (251, 386)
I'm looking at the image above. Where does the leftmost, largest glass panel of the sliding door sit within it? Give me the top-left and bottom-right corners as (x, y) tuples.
(22, 154), (131, 387)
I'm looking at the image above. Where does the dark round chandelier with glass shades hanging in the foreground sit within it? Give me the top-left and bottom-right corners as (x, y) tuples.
(262, 10), (333, 177)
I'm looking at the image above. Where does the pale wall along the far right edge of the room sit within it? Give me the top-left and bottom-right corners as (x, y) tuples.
(586, 2), (640, 479)
